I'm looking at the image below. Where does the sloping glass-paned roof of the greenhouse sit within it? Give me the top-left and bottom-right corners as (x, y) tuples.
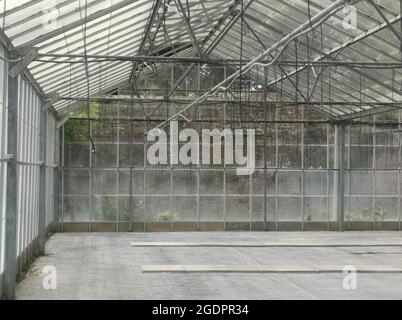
(0, 0), (402, 116)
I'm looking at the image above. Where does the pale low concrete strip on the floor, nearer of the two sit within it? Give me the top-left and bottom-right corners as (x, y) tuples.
(141, 265), (402, 273)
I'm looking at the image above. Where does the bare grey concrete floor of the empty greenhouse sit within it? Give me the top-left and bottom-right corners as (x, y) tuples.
(17, 232), (402, 299)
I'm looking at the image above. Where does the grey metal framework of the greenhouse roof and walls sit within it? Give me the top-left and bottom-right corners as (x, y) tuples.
(0, 0), (402, 299)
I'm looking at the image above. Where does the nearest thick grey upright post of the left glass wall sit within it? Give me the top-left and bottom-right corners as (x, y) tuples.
(4, 56), (20, 300)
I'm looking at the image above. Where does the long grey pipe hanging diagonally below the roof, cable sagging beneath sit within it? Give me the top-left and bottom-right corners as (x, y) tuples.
(146, 0), (354, 134)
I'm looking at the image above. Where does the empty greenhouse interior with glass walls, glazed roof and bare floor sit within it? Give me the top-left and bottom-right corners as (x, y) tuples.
(0, 0), (402, 299)
